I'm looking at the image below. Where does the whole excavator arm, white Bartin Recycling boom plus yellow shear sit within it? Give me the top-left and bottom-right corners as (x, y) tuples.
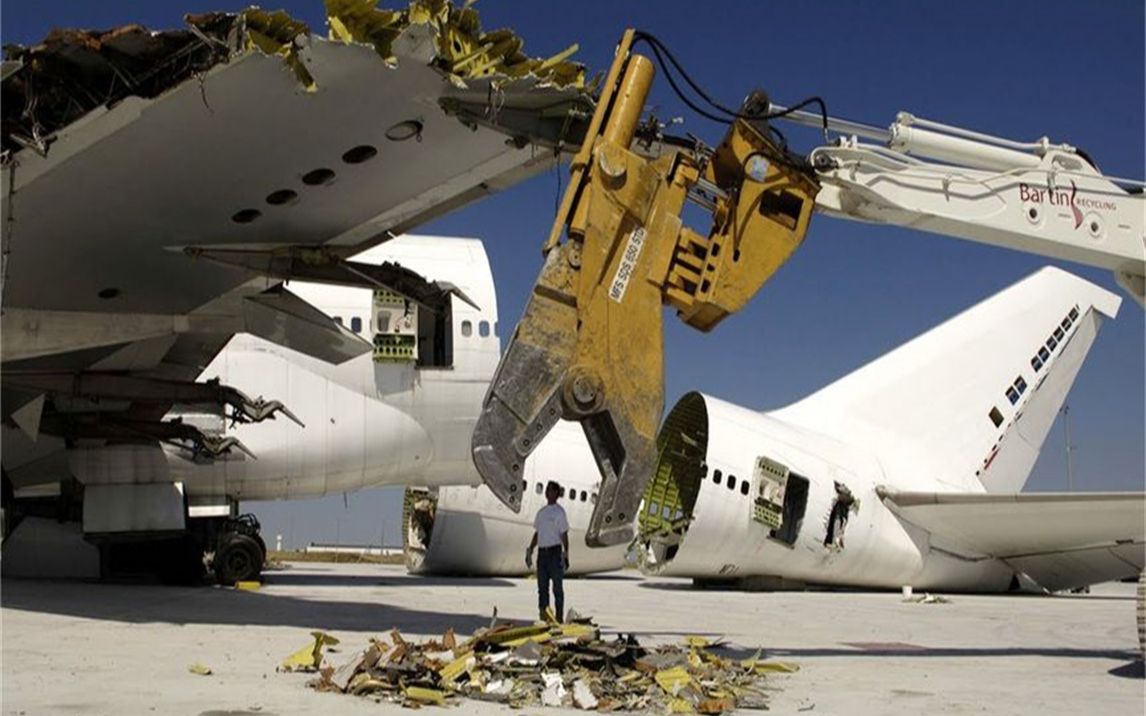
(472, 30), (1146, 546)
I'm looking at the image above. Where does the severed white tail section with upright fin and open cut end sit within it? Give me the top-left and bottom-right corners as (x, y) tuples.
(637, 268), (1127, 591)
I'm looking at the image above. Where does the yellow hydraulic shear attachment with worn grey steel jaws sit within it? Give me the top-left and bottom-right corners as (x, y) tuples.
(473, 30), (819, 546)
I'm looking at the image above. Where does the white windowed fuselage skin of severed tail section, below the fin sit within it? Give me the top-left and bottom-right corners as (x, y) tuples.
(645, 396), (1013, 591)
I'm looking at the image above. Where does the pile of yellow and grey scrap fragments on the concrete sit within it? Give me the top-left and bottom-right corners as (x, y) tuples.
(282, 619), (796, 714)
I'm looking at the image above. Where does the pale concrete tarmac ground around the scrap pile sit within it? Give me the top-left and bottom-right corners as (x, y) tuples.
(0, 564), (1146, 716)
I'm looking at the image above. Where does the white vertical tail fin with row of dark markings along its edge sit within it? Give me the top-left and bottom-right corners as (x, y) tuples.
(774, 268), (1121, 491)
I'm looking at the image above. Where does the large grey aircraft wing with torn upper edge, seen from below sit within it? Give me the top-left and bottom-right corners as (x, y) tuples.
(0, 0), (592, 463)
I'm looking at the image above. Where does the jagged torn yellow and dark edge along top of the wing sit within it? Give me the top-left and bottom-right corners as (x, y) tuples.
(2, 0), (591, 155)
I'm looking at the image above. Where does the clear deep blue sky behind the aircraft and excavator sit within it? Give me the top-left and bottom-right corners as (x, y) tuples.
(2, 0), (1146, 544)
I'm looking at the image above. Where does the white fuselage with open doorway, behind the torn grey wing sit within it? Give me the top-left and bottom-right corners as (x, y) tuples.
(167, 237), (500, 503)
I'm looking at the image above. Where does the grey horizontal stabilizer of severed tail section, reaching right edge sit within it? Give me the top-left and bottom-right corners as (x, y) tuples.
(881, 490), (1146, 591)
